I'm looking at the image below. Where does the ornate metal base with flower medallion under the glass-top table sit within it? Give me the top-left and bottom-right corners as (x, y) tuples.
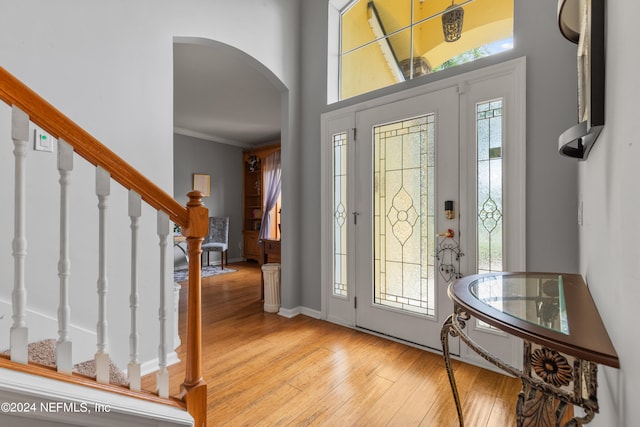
(440, 307), (598, 427)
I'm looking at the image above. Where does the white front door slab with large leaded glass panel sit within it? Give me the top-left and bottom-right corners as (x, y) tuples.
(354, 87), (459, 348)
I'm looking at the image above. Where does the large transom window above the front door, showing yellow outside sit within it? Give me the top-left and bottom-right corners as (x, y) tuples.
(336, 0), (513, 102)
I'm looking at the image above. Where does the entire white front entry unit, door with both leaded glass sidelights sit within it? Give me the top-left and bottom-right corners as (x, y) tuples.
(322, 59), (526, 365)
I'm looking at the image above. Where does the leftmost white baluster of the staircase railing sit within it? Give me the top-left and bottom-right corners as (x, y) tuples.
(10, 106), (29, 364)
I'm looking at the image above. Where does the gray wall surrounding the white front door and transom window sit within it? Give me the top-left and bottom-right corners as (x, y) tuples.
(300, 0), (578, 310)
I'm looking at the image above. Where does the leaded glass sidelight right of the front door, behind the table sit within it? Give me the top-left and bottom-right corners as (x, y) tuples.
(476, 99), (503, 273)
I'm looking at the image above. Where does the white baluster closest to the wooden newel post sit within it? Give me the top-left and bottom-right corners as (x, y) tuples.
(156, 211), (169, 398)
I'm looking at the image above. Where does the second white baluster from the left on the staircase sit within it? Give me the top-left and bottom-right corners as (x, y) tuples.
(56, 139), (73, 375)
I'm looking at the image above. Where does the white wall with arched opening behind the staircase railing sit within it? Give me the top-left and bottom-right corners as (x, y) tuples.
(0, 0), (298, 365)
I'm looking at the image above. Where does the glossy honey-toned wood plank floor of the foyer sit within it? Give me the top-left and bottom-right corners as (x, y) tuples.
(143, 263), (520, 427)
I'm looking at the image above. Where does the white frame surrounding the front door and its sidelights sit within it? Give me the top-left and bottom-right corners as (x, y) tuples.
(321, 57), (526, 365)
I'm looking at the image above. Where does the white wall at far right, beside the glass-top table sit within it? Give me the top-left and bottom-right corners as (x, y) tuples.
(579, 0), (640, 427)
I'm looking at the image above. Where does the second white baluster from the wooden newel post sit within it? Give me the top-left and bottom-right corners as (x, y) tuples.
(127, 190), (142, 391)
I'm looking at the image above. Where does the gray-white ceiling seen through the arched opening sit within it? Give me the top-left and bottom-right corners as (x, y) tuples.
(173, 42), (281, 148)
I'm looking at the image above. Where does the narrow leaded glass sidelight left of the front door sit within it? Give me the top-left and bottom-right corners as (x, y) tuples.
(333, 132), (348, 297)
